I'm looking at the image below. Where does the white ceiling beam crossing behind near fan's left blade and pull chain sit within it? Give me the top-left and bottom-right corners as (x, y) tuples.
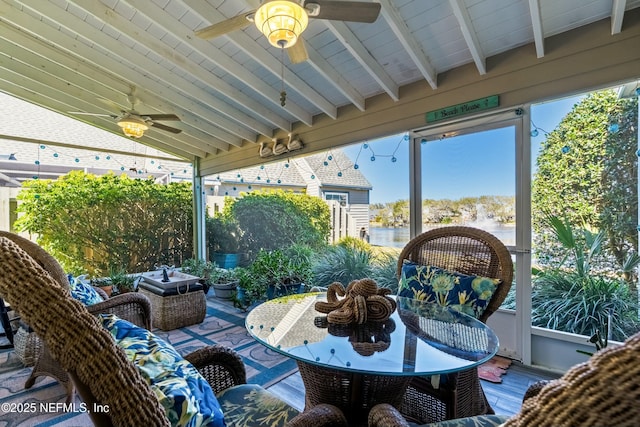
(183, 0), (338, 119)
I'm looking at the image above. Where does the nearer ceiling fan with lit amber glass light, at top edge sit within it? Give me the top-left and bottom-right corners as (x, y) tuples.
(195, 0), (381, 64)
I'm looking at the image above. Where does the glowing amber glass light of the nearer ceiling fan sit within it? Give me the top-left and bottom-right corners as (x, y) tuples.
(254, 0), (309, 49)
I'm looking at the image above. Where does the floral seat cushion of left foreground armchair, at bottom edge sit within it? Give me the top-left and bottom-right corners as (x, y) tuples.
(218, 384), (298, 427)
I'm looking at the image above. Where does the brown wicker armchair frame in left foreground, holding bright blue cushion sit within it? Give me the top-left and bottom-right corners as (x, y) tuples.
(0, 237), (346, 427)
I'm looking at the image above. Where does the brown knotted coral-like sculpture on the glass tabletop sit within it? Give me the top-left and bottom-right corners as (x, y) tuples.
(315, 278), (396, 325)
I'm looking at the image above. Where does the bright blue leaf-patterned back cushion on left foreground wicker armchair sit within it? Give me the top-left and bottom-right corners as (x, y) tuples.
(100, 314), (225, 427)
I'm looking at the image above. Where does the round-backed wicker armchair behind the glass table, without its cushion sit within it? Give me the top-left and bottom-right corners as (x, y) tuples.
(397, 226), (513, 423)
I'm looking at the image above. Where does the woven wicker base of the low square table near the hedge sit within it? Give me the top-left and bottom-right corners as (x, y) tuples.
(138, 282), (207, 331)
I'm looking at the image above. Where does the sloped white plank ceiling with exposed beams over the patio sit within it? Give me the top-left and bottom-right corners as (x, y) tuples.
(0, 0), (640, 171)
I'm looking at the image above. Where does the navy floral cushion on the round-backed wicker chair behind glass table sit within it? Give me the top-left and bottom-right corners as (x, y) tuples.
(398, 260), (500, 318)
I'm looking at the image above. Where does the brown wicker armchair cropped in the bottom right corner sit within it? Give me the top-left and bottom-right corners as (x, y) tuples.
(369, 333), (640, 427)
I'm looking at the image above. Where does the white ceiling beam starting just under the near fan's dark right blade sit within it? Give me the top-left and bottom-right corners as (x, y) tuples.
(324, 21), (400, 101)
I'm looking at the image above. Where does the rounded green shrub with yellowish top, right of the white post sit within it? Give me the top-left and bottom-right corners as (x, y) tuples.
(224, 190), (330, 256)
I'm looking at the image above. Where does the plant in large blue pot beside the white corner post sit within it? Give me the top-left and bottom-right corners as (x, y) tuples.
(206, 215), (241, 269)
